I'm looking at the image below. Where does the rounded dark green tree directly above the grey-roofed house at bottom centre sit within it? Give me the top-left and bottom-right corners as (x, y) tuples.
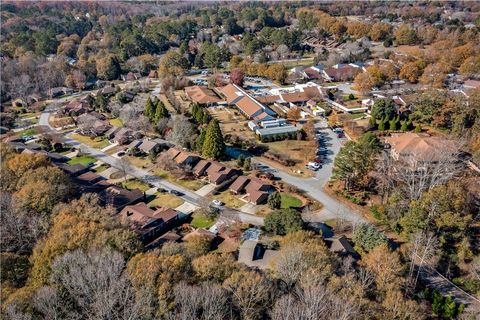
(264, 209), (303, 235)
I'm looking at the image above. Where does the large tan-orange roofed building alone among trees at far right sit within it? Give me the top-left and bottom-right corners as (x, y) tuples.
(385, 132), (458, 162)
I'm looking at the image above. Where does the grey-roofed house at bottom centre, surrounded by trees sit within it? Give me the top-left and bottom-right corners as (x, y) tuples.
(238, 240), (279, 269)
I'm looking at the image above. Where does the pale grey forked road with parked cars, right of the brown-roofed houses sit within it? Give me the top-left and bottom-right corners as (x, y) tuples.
(253, 129), (367, 223)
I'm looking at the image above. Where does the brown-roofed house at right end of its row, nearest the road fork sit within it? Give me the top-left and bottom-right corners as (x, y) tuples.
(230, 176), (275, 204)
